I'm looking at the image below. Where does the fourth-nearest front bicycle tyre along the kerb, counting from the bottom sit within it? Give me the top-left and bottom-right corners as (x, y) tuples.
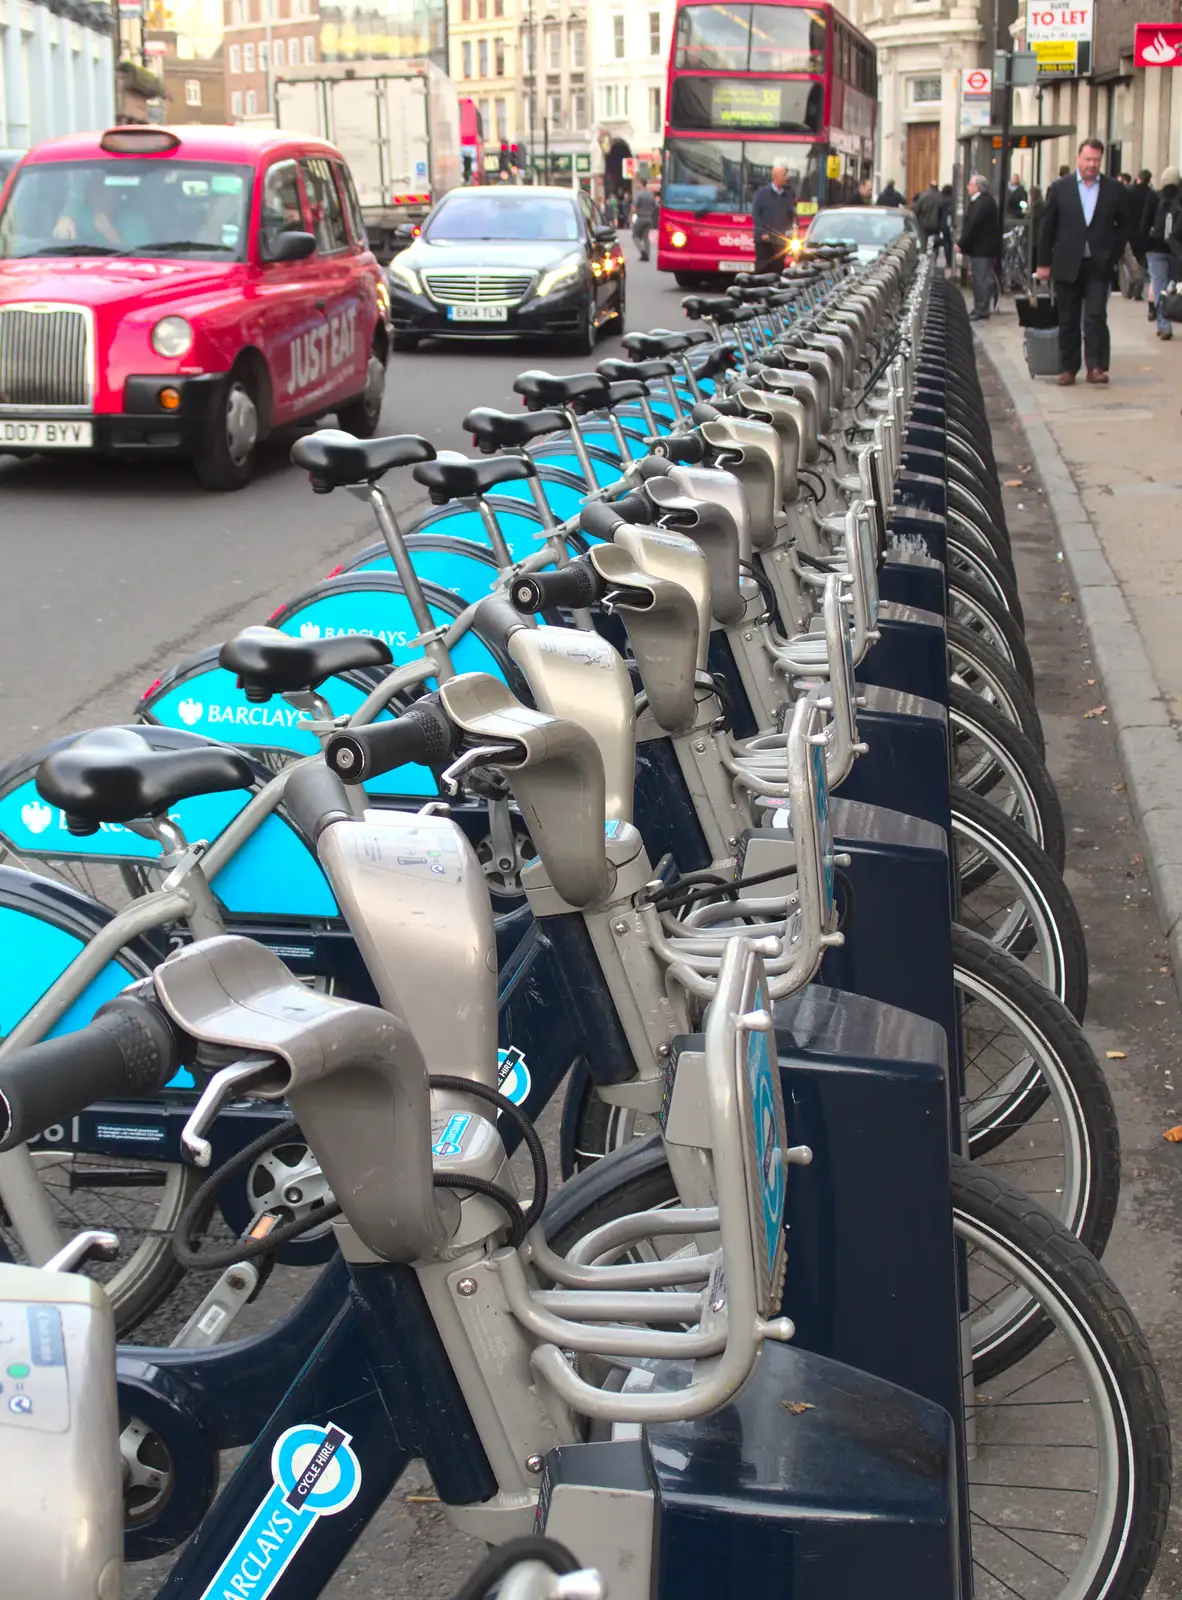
(948, 683), (1067, 872)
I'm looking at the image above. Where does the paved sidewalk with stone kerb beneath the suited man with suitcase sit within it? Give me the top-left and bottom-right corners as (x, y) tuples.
(977, 298), (1182, 987)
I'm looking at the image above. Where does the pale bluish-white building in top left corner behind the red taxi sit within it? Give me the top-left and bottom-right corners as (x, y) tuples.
(0, 0), (115, 150)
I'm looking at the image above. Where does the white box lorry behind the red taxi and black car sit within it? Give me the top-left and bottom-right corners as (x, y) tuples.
(275, 61), (461, 261)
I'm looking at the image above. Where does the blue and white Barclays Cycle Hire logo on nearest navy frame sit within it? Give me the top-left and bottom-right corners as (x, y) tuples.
(202, 1422), (361, 1600)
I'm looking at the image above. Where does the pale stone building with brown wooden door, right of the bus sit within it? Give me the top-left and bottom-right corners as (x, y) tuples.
(846, 0), (1014, 200)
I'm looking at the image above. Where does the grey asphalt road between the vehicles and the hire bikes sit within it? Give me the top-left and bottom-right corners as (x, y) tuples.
(0, 240), (683, 758)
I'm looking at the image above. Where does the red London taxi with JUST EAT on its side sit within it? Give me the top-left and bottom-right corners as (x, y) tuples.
(0, 126), (390, 490)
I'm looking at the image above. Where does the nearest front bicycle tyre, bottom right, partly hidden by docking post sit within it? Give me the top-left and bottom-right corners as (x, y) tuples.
(550, 1157), (1172, 1600)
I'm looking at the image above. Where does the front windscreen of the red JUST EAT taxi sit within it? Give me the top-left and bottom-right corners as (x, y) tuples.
(0, 157), (253, 261)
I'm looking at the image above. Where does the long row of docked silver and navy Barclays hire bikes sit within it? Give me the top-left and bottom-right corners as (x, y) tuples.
(0, 240), (1171, 1600)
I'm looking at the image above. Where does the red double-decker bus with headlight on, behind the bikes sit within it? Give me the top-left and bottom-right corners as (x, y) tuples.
(657, 0), (878, 288)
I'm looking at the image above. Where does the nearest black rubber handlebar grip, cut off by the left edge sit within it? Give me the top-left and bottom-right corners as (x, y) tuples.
(0, 995), (189, 1150)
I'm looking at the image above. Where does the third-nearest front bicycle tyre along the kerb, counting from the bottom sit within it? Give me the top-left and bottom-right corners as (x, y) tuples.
(952, 784), (1088, 1021)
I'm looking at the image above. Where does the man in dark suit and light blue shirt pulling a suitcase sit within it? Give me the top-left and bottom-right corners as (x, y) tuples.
(1036, 139), (1129, 387)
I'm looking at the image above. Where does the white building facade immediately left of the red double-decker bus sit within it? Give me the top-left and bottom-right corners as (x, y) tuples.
(590, 0), (673, 200)
